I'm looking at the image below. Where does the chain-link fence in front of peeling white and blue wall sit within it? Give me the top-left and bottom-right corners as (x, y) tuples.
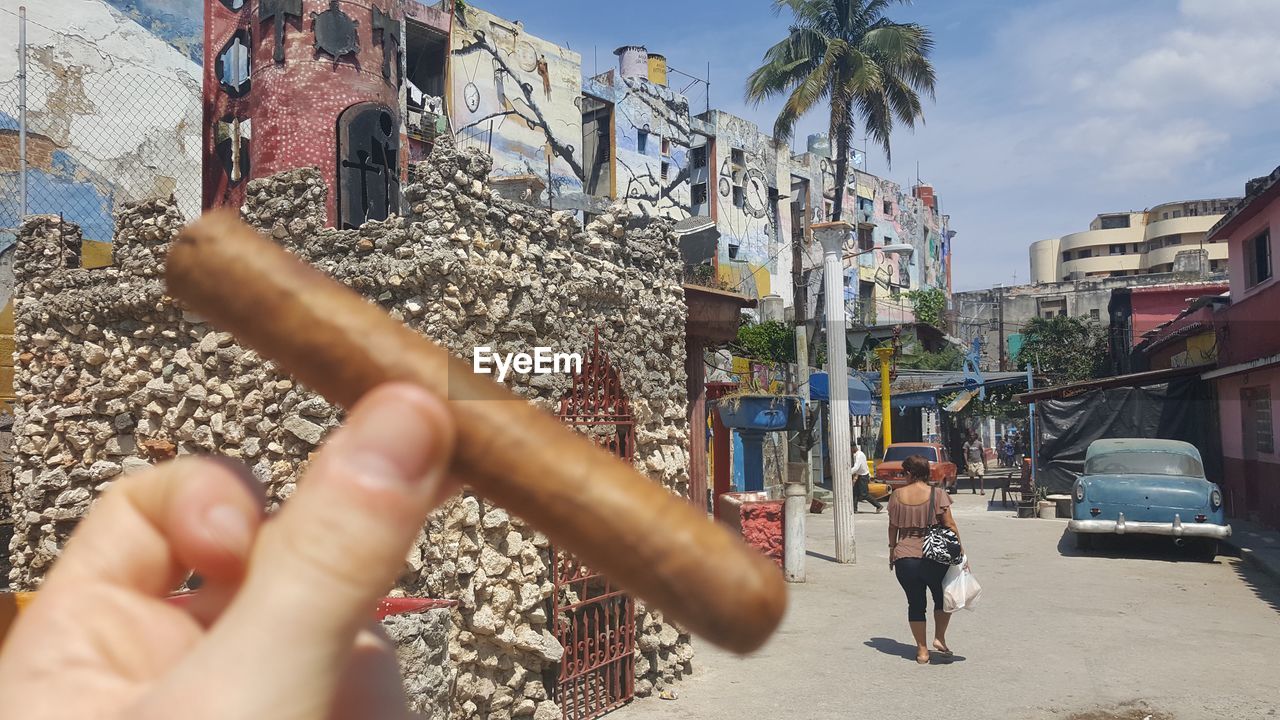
(0, 6), (202, 250)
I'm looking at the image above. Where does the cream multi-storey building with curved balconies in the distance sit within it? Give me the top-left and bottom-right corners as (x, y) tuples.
(1030, 197), (1239, 283)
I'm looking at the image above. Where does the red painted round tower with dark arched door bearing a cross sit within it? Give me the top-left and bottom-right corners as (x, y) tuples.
(204, 0), (404, 227)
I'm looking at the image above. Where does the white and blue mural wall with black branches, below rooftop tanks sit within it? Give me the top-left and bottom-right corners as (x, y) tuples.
(584, 72), (694, 220)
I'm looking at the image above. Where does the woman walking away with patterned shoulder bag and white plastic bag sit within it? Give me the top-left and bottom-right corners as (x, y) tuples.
(888, 455), (960, 665)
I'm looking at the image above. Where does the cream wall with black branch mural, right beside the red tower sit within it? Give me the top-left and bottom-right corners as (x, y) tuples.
(448, 5), (584, 195)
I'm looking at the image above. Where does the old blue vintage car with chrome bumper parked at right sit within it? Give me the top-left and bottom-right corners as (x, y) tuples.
(1068, 438), (1231, 560)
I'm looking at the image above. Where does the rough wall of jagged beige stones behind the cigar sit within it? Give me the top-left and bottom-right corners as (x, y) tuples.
(10, 142), (692, 719)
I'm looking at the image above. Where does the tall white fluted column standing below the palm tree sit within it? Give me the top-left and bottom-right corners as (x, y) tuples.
(813, 222), (858, 564)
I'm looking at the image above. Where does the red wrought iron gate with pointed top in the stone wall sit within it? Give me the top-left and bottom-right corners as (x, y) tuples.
(552, 333), (636, 720)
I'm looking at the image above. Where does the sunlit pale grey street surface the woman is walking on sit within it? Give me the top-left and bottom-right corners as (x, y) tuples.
(611, 491), (1280, 720)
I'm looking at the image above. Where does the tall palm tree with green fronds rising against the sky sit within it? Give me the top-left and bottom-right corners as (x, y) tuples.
(746, 0), (936, 220)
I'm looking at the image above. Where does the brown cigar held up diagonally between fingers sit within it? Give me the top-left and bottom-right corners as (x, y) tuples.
(166, 210), (786, 653)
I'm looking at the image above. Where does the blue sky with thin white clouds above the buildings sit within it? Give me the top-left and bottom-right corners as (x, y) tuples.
(474, 0), (1280, 290)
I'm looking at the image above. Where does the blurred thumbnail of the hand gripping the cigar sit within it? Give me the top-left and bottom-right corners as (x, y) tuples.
(342, 387), (444, 489)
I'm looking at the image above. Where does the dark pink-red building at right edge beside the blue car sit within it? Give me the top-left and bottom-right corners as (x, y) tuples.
(1204, 168), (1280, 527)
